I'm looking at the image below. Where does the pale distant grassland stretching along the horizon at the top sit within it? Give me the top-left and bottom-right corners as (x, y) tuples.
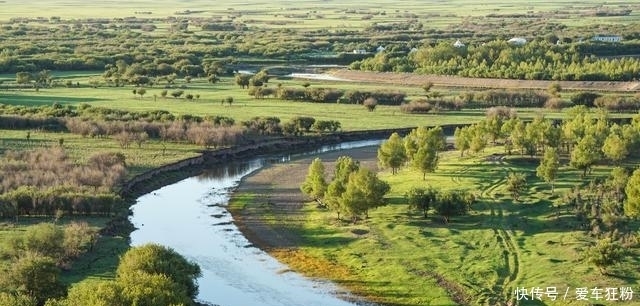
(0, 0), (639, 30)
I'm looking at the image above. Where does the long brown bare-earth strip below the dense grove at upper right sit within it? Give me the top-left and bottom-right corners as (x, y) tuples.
(329, 69), (640, 92)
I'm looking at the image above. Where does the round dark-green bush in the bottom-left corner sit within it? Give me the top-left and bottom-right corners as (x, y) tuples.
(0, 252), (64, 305)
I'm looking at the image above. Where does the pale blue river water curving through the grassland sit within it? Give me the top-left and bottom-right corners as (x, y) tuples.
(130, 141), (380, 306)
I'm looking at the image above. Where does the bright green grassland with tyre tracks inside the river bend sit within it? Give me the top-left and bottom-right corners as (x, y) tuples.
(233, 148), (640, 305)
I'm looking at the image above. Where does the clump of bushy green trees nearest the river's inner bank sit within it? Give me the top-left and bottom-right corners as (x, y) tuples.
(300, 156), (391, 223)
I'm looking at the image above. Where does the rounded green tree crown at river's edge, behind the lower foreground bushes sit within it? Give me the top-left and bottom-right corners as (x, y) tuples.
(116, 244), (201, 298)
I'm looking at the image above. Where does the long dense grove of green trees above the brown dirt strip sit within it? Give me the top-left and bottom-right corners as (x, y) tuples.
(350, 40), (640, 81)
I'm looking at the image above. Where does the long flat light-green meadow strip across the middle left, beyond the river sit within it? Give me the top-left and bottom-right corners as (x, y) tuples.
(0, 75), (484, 130)
